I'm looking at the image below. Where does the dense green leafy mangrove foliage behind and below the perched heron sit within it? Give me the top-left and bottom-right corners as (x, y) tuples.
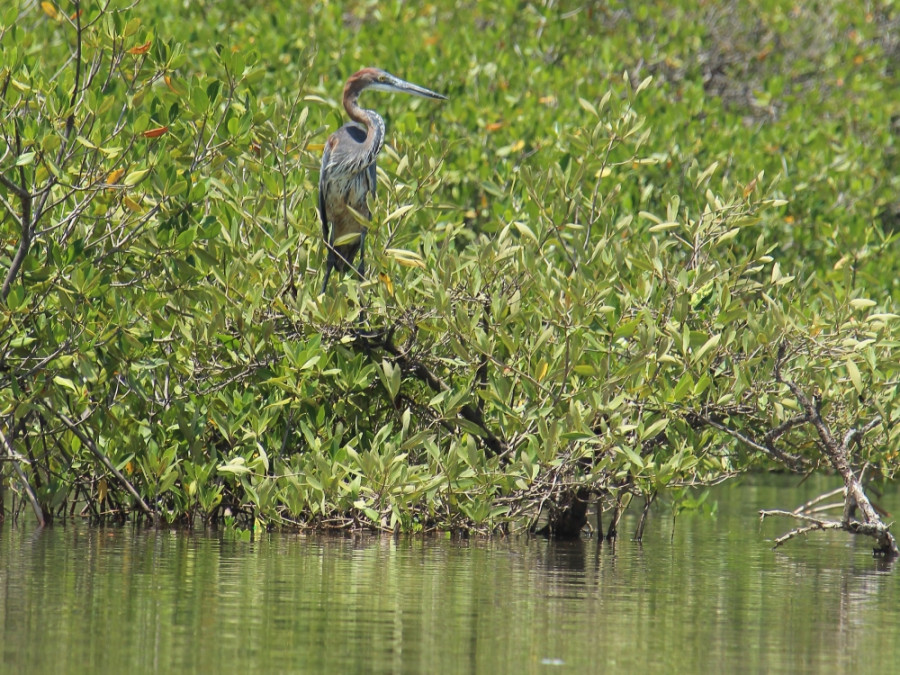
(0, 0), (900, 531)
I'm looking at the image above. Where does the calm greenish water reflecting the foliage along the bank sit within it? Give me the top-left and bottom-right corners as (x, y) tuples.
(0, 477), (900, 673)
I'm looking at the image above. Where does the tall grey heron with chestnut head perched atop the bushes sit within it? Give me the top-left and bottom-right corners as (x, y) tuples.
(319, 68), (447, 293)
